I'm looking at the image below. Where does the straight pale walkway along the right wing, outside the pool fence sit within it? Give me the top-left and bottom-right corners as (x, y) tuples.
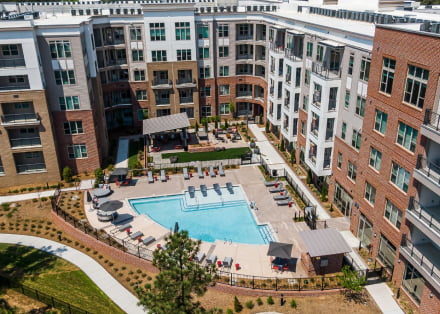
(249, 124), (330, 220)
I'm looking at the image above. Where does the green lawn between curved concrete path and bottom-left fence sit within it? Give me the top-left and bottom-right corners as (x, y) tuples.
(0, 243), (124, 313)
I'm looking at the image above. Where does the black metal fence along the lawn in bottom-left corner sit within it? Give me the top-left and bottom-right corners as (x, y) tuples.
(0, 276), (90, 314)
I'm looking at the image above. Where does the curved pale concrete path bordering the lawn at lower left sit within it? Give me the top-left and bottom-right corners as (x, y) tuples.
(0, 234), (145, 314)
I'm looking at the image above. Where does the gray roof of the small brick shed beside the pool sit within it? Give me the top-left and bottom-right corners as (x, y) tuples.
(299, 228), (351, 257)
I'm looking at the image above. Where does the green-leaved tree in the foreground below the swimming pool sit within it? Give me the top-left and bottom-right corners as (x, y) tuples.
(136, 231), (216, 314)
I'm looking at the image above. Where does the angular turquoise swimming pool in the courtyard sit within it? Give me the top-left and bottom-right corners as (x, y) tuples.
(129, 186), (272, 244)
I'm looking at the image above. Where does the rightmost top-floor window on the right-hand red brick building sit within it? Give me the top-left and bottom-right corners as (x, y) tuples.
(403, 65), (429, 108)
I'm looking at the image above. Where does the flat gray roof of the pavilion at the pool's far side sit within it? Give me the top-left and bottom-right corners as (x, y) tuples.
(143, 112), (190, 135)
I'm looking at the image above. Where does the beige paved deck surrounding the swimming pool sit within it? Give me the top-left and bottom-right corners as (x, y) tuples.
(86, 166), (326, 278)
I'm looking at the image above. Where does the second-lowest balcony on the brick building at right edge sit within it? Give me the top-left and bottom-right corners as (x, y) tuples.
(406, 197), (440, 243)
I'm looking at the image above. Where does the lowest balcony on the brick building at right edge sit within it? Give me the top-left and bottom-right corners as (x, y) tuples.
(400, 239), (440, 291)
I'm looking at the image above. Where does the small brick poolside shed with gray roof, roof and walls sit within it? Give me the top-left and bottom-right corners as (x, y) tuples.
(299, 228), (351, 276)
